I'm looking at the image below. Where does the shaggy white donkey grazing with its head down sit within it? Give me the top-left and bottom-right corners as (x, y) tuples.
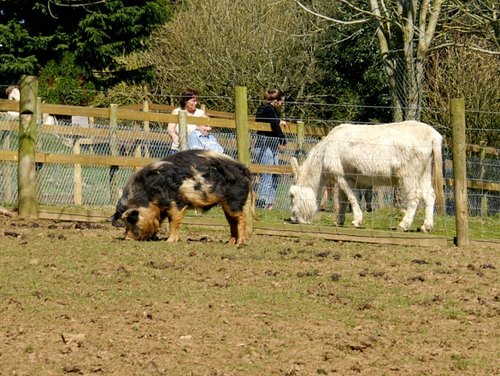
(290, 121), (443, 232)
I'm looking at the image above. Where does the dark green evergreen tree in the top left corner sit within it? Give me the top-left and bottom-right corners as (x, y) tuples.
(0, 0), (170, 103)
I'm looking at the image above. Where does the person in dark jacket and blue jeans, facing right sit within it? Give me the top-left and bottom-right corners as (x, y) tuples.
(255, 89), (286, 209)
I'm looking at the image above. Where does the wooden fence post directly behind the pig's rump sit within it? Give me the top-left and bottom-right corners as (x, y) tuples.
(234, 86), (255, 234)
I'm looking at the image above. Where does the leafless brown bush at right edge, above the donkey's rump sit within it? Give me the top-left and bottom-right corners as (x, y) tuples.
(422, 35), (500, 149)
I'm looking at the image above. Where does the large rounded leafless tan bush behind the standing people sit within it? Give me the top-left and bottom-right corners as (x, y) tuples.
(143, 0), (319, 111)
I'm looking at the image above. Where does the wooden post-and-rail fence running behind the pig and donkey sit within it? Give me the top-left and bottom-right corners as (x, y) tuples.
(0, 76), (500, 247)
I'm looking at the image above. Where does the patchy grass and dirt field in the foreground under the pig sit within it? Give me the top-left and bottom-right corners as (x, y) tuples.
(0, 216), (500, 376)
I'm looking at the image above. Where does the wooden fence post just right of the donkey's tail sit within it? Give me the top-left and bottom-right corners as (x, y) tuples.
(450, 98), (469, 247)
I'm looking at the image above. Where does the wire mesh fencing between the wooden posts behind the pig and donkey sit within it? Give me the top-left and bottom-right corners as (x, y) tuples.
(0, 110), (500, 242)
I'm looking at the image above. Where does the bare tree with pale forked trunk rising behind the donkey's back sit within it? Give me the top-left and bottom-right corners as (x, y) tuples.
(294, 0), (499, 121)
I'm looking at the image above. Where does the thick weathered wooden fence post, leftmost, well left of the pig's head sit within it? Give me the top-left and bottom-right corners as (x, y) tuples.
(17, 75), (38, 219)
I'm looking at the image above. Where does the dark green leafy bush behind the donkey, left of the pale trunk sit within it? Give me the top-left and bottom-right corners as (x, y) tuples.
(311, 23), (391, 122)
